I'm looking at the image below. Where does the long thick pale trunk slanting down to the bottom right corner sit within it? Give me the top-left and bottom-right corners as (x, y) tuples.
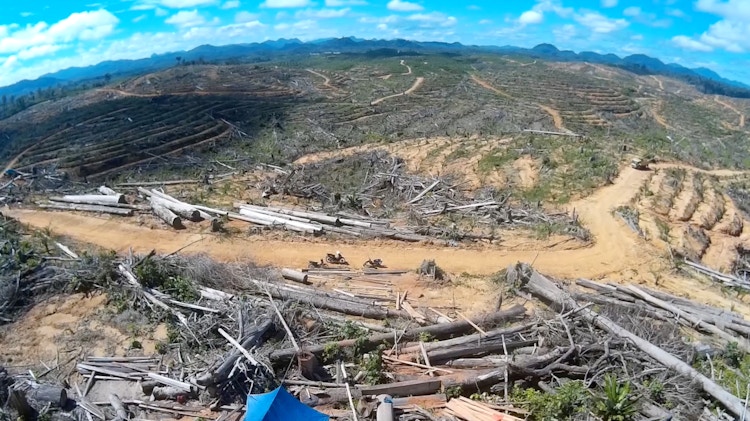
(507, 264), (745, 418)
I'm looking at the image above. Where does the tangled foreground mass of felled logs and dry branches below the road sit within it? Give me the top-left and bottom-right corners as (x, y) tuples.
(2, 228), (750, 421)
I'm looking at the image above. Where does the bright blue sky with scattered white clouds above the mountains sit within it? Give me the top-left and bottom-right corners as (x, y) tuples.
(0, 0), (750, 86)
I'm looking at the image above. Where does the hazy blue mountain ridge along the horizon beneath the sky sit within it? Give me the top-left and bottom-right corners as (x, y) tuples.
(0, 37), (750, 98)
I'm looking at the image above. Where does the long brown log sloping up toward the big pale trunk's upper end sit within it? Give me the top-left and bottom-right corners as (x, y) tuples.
(269, 305), (526, 363)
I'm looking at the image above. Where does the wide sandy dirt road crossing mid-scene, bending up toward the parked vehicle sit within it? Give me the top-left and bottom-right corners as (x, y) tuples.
(4, 168), (653, 278)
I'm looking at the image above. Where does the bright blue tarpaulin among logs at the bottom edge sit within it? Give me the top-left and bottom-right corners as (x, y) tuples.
(245, 387), (328, 421)
